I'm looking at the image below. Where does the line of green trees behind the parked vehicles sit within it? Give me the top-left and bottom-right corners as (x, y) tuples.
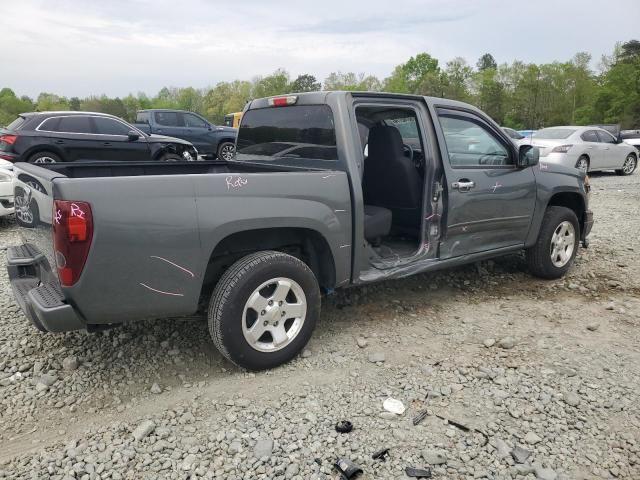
(0, 40), (640, 129)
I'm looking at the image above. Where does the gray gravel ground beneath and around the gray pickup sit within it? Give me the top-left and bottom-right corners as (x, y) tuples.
(0, 174), (640, 480)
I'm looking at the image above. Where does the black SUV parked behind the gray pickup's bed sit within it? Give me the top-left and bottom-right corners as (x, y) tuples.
(0, 112), (198, 163)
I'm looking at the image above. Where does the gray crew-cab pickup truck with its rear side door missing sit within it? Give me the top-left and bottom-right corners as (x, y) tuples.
(8, 92), (593, 370)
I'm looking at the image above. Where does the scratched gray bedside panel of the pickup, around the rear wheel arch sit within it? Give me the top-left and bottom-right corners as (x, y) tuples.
(54, 171), (351, 323)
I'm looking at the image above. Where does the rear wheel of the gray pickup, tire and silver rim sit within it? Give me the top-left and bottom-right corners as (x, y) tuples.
(208, 251), (320, 370)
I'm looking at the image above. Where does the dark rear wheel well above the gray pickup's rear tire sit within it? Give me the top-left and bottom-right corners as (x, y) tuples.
(202, 228), (336, 295)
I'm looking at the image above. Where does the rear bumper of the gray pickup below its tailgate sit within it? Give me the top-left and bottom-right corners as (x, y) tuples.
(7, 244), (86, 332)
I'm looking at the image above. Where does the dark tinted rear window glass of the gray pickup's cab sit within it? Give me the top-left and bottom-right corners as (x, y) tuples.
(236, 105), (338, 166)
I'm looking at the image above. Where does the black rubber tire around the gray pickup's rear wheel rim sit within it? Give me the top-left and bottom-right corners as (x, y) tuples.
(208, 251), (320, 370)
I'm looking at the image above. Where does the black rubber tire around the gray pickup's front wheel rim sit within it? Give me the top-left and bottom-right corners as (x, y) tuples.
(526, 206), (580, 279)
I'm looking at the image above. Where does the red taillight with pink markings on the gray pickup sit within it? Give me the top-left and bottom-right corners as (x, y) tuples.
(51, 200), (93, 287)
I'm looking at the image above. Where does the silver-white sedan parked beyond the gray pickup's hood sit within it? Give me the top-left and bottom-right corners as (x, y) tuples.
(531, 127), (638, 175)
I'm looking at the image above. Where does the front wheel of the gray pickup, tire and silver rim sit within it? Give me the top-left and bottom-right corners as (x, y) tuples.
(527, 206), (580, 279)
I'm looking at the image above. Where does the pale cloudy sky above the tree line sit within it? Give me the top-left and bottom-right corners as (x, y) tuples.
(0, 0), (640, 97)
